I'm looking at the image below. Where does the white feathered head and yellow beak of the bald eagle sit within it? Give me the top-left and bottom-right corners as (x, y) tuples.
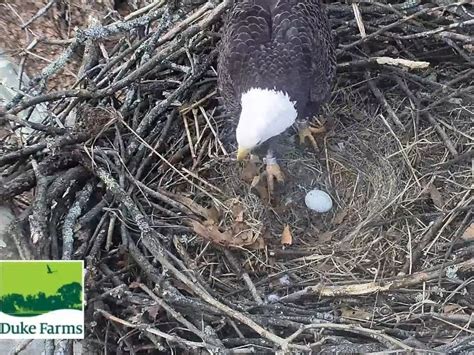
(236, 88), (297, 160)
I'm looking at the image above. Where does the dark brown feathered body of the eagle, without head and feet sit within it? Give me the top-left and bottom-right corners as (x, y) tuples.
(218, 0), (336, 119)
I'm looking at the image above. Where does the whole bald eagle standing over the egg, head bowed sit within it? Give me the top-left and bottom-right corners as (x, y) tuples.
(217, 0), (336, 199)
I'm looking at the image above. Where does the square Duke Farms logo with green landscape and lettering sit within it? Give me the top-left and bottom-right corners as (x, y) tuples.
(0, 260), (84, 339)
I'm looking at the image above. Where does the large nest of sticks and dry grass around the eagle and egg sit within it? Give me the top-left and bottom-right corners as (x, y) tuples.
(0, 0), (474, 354)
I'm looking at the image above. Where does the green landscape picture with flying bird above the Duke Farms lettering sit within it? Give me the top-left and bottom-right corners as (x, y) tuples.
(0, 261), (83, 317)
